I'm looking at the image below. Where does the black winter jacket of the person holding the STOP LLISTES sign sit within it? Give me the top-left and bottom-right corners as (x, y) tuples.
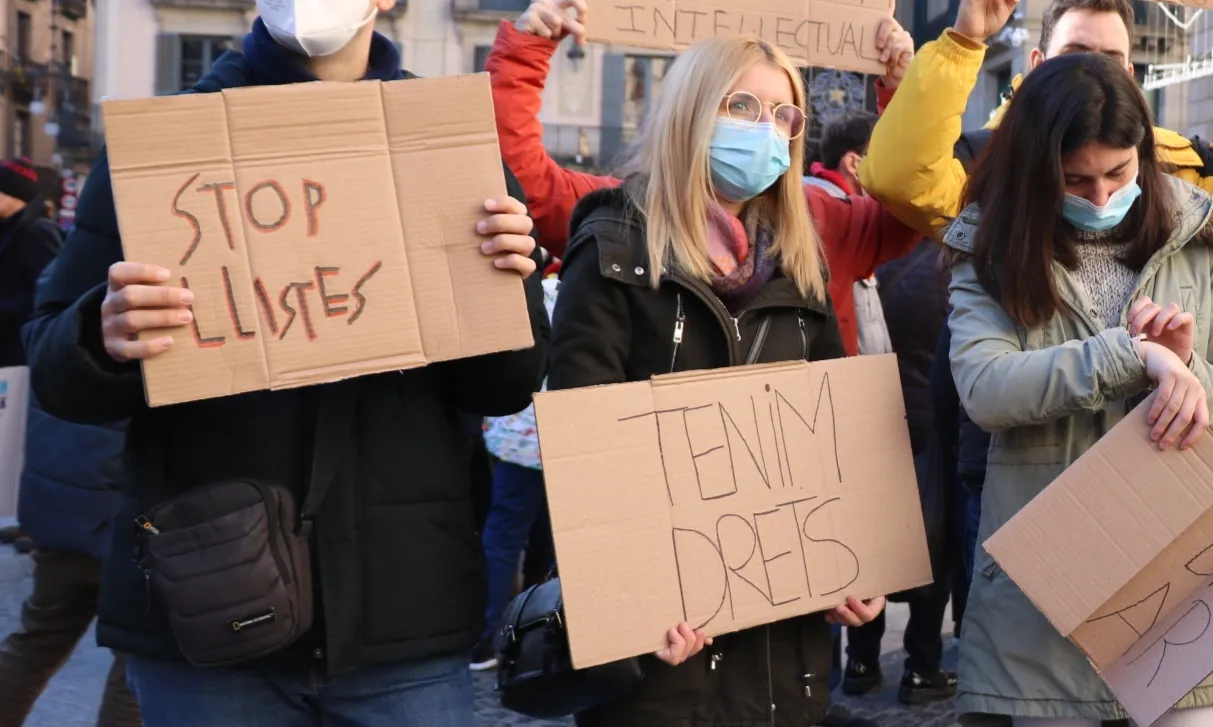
(25, 48), (551, 674)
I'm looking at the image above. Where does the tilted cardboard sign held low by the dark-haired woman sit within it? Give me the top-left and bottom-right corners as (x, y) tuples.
(985, 399), (1213, 725)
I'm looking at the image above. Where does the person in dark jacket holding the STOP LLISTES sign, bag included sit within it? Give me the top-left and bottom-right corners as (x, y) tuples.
(25, 0), (549, 727)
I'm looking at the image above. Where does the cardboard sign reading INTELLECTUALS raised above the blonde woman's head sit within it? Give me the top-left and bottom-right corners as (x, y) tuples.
(586, 0), (893, 74)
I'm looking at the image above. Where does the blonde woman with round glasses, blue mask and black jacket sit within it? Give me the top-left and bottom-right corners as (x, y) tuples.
(548, 25), (884, 727)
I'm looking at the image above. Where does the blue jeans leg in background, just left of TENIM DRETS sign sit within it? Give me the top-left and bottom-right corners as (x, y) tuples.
(484, 461), (552, 640)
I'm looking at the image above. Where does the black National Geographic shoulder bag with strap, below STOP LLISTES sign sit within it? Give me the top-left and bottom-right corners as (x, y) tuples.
(135, 379), (359, 666)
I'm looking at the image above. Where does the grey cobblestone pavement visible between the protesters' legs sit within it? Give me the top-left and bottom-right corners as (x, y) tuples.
(0, 546), (956, 727)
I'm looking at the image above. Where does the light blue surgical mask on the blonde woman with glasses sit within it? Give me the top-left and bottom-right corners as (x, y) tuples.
(708, 118), (792, 201)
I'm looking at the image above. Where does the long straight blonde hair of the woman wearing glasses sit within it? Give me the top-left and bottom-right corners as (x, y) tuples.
(623, 38), (826, 300)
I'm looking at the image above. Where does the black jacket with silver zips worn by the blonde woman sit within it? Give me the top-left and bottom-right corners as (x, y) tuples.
(548, 189), (845, 727)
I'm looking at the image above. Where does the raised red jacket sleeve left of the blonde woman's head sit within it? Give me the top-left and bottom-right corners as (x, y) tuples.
(484, 21), (620, 257)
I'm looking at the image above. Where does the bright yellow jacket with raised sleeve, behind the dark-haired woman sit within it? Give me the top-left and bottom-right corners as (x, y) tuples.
(859, 30), (1213, 238)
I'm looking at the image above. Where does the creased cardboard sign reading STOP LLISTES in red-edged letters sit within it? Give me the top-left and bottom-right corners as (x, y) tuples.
(104, 74), (534, 407)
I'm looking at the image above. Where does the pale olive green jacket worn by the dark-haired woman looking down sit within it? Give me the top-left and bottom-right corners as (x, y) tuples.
(944, 177), (1213, 726)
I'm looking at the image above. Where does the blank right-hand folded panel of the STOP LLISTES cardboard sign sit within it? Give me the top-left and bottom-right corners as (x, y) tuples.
(383, 75), (530, 362)
